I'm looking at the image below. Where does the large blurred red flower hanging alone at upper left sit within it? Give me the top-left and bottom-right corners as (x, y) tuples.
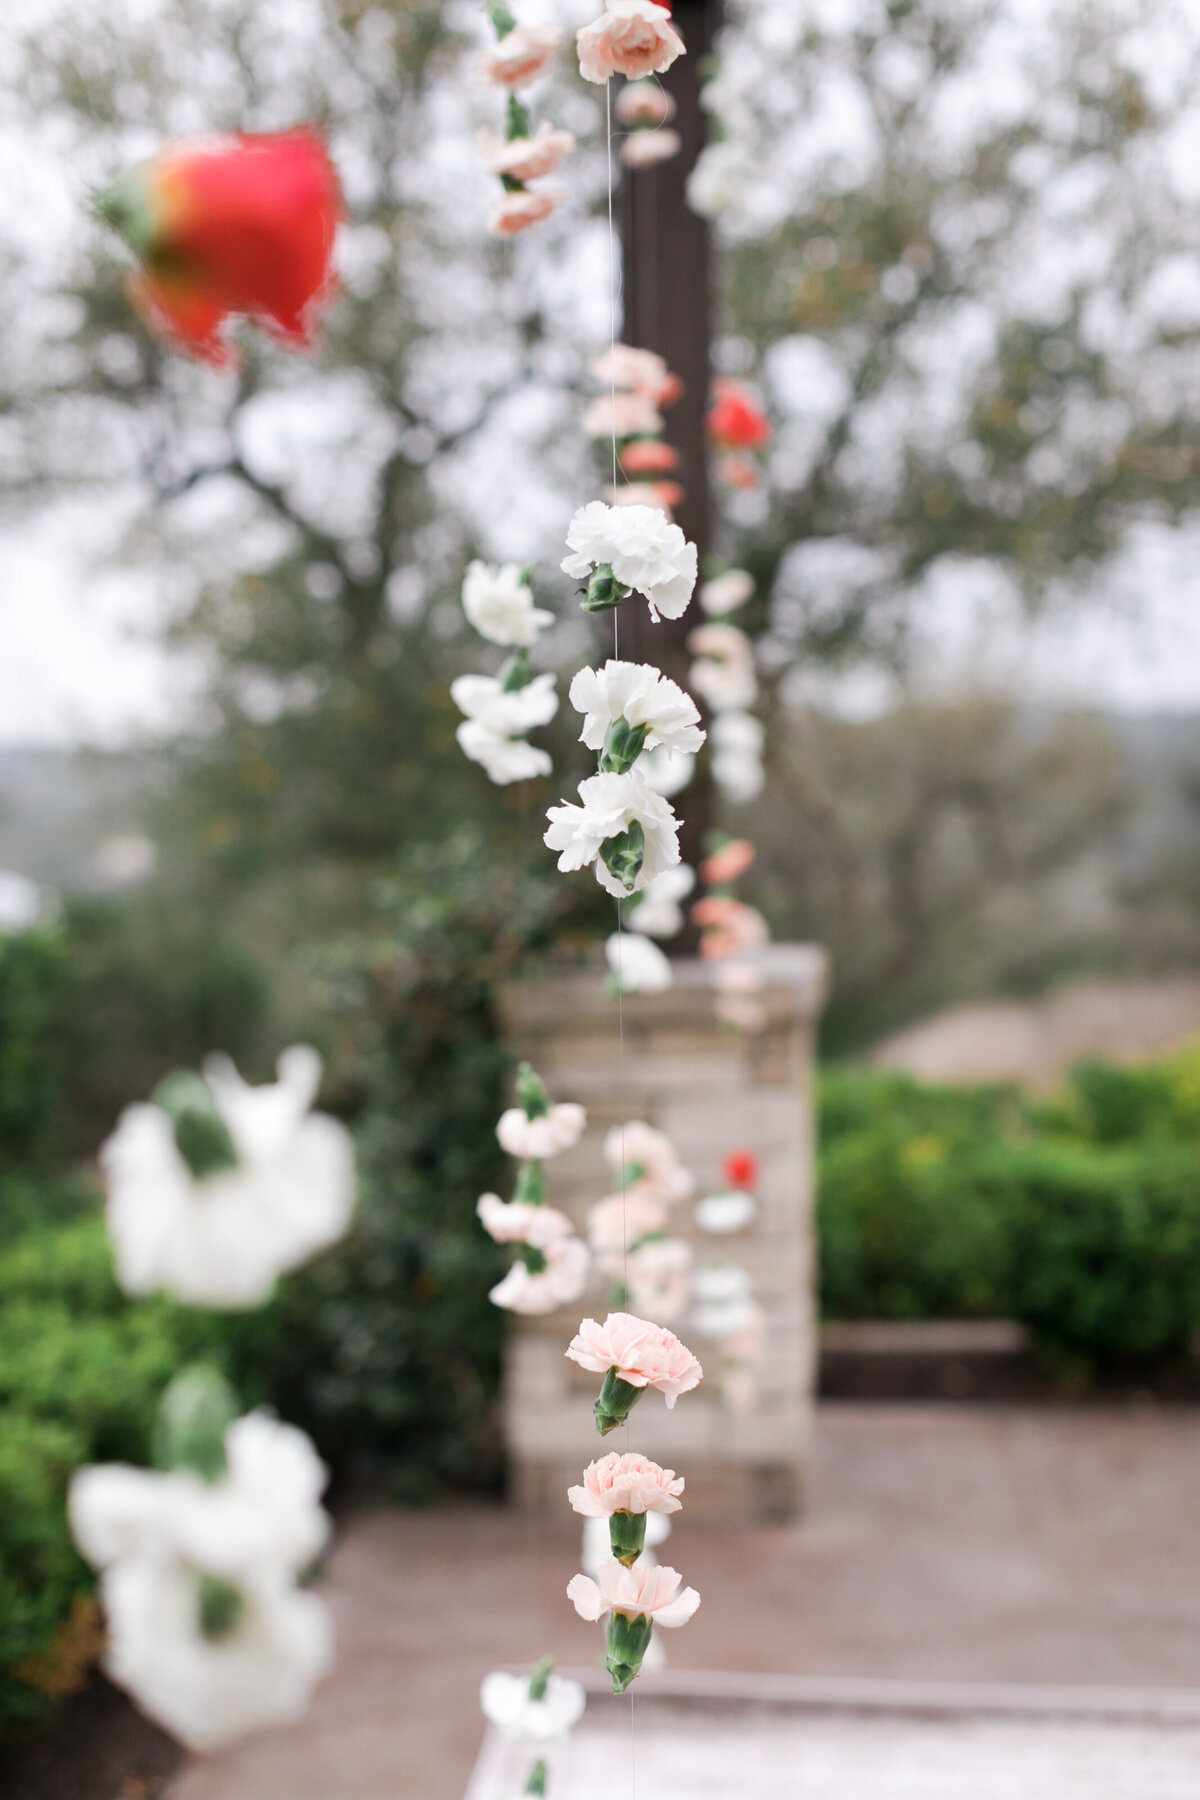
(99, 126), (342, 367)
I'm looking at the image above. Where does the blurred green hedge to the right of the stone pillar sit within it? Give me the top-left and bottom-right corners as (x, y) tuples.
(819, 1049), (1200, 1370)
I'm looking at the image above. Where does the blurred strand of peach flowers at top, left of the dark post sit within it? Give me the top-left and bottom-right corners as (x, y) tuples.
(479, 0), (576, 238)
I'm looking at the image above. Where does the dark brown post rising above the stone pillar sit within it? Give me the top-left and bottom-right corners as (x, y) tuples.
(621, 0), (721, 862)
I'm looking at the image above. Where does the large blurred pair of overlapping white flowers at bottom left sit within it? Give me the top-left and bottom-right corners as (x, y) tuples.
(70, 1413), (333, 1750)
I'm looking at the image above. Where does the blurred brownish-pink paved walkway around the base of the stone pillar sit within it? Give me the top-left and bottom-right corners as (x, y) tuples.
(171, 1406), (1200, 1800)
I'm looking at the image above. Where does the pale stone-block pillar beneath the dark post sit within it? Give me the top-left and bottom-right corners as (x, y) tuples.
(504, 945), (826, 1519)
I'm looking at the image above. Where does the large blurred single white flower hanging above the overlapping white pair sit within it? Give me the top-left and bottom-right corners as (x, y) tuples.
(101, 1044), (354, 1309)
